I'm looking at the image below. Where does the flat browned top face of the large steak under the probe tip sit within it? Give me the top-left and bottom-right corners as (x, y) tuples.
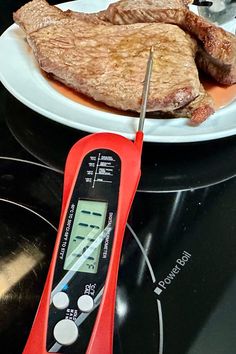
(28, 21), (200, 111)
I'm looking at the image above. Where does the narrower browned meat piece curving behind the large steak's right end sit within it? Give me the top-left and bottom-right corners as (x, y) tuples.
(103, 0), (236, 84)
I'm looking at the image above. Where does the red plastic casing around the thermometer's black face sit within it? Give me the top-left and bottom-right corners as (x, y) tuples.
(23, 132), (143, 354)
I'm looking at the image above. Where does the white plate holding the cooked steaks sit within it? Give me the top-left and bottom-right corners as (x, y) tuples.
(0, 0), (236, 142)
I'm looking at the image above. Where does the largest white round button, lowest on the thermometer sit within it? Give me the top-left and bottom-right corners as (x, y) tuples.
(53, 319), (79, 345)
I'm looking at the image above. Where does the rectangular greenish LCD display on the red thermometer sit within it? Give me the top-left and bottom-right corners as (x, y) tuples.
(63, 200), (107, 274)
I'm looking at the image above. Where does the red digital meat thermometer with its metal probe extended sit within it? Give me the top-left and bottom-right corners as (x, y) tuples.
(23, 48), (153, 354)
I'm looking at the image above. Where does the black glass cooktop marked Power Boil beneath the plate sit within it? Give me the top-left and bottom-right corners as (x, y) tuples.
(0, 1), (236, 354)
